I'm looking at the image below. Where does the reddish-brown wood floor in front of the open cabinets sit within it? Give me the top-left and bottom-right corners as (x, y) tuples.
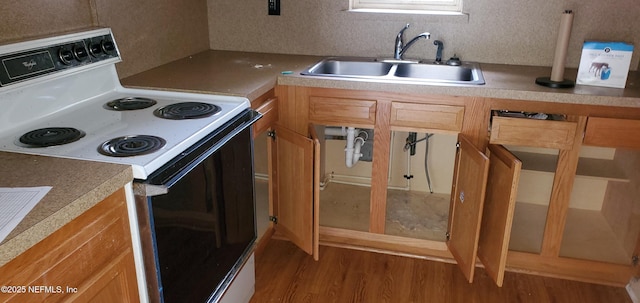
(251, 239), (631, 303)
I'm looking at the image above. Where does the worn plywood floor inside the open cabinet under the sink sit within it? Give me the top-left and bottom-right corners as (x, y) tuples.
(320, 183), (450, 241)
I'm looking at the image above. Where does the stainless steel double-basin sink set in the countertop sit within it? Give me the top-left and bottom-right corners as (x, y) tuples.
(301, 57), (485, 85)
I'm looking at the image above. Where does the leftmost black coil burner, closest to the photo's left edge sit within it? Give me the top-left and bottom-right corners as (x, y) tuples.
(19, 127), (85, 147)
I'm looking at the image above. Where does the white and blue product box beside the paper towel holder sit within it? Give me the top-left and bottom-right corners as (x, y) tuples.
(576, 41), (633, 88)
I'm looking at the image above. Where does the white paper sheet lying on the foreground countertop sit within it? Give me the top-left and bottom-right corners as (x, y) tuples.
(0, 186), (51, 242)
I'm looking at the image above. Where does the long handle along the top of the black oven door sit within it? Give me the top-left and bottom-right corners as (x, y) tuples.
(138, 109), (262, 197)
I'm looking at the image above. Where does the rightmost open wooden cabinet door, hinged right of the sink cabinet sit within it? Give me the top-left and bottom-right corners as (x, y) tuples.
(478, 145), (522, 286)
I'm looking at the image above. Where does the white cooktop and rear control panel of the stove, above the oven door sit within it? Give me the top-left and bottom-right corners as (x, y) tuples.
(0, 29), (250, 179)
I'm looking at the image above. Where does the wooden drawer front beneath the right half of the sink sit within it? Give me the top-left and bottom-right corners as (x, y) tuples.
(390, 102), (464, 133)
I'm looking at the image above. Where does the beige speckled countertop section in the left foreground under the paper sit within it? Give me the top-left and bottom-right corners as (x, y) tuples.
(0, 152), (133, 266)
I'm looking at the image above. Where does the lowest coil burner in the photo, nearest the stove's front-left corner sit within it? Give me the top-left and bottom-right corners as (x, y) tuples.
(98, 135), (166, 157)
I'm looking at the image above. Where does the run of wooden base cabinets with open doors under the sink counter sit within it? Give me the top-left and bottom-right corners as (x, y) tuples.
(273, 87), (640, 286)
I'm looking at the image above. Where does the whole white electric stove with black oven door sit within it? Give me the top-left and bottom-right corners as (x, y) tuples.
(0, 28), (260, 303)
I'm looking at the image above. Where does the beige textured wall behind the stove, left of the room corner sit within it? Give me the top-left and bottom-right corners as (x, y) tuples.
(0, 0), (209, 78)
